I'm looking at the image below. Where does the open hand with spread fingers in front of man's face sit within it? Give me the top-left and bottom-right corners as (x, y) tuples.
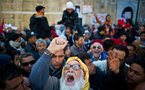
(108, 50), (121, 74)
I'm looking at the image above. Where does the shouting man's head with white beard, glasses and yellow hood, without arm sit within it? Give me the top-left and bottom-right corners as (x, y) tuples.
(60, 57), (89, 90)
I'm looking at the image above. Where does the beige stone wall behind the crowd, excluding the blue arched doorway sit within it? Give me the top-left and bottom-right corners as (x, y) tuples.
(0, 0), (145, 28)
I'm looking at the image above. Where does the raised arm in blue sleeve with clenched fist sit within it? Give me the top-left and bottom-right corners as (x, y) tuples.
(29, 37), (67, 90)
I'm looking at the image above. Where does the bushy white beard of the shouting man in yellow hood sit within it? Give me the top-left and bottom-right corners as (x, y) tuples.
(60, 73), (85, 90)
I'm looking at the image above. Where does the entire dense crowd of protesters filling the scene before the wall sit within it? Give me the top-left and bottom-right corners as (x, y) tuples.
(0, 2), (145, 90)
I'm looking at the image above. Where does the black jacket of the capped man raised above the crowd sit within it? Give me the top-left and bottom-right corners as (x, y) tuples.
(29, 14), (51, 38)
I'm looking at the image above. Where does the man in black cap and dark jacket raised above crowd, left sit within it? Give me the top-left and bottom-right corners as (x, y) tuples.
(29, 6), (51, 38)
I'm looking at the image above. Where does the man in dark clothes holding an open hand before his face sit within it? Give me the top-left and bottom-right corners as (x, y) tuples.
(93, 45), (128, 90)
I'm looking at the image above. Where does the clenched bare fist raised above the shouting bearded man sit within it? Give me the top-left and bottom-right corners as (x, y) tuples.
(47, 37), (68, 54)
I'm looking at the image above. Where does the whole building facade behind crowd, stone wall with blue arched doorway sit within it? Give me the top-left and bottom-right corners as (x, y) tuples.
(0, 0), (145, 28)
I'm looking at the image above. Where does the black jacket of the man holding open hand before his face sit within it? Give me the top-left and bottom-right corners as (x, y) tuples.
(105, 63), (128, 90)
